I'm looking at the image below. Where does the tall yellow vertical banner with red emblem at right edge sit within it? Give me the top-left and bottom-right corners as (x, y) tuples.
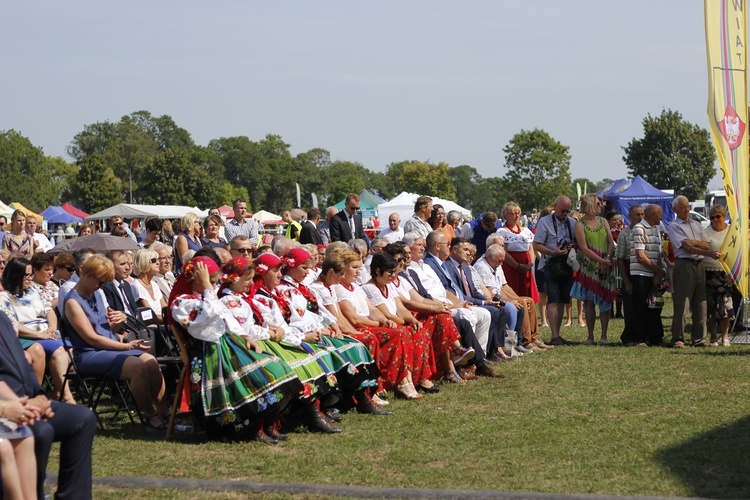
(704, 0), (750, 298)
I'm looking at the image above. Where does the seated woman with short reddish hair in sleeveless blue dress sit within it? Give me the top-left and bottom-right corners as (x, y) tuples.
(63, 254), (169, 431)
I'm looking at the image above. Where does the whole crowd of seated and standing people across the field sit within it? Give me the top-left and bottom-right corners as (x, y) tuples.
(0, 189), (734, 497)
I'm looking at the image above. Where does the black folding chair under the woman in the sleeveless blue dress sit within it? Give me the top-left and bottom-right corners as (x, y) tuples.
(58, 318), (143, 430)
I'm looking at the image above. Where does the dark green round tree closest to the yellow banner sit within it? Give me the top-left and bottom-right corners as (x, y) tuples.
(622, 109), (716, 200)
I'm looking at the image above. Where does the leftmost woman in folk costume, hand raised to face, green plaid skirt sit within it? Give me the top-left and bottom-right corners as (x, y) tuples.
(170, 257), (303, 444)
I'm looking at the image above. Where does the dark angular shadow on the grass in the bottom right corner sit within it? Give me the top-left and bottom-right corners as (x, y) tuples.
(655, 416), (750, 498)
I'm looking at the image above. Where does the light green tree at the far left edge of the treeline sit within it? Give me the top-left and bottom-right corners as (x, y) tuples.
(0, 130), (70, 211)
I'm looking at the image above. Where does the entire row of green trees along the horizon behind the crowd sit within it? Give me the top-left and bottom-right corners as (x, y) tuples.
(0, 111), (714, 214)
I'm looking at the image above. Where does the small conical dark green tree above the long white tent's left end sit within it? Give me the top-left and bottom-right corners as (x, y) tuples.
(72, 153), (123, 213)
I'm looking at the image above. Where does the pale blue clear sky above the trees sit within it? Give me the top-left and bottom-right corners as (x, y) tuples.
(0, 0), (719, 188)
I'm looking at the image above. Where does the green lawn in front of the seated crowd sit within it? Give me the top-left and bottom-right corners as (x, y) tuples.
(50, 302), (750, 498)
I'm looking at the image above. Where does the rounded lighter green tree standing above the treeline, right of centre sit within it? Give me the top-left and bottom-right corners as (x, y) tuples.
(503, 129), (571, 211)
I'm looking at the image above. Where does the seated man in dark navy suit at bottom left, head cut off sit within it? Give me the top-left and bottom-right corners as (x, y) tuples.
(0, 313), (96, 498)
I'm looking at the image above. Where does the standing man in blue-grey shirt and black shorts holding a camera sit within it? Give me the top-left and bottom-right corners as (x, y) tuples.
(533, 196), (575, 346)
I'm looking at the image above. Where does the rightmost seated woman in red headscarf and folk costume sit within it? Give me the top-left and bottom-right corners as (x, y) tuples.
(276, 248), (390, 415)
